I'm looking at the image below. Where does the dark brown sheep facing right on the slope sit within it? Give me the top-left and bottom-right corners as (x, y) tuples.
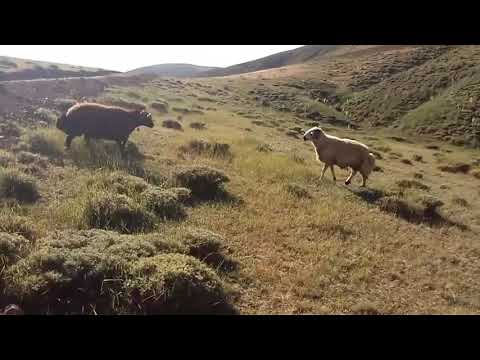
(57, 103), (153, 154)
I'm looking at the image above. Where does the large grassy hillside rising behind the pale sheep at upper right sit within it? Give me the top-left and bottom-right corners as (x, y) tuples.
(204, 45), (480, 147)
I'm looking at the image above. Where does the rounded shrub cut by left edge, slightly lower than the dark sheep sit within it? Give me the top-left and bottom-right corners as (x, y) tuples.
(0, 169), (40, 203)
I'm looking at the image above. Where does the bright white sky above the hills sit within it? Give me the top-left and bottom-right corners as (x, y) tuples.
(0, 45), (302, 71)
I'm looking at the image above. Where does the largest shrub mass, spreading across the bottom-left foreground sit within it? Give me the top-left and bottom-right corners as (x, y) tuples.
(1, 230), (232, 314)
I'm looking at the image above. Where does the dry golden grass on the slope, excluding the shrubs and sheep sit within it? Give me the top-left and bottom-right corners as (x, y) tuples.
(3, 79), (480, 314)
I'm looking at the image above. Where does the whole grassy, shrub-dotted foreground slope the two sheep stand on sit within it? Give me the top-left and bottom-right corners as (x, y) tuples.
(0, 71), (480, 314)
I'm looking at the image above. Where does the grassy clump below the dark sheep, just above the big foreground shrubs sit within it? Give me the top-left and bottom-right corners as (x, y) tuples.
(84, 192), (154, 234)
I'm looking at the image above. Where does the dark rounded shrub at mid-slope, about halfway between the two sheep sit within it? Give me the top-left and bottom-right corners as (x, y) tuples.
(172, 166), (229, 200)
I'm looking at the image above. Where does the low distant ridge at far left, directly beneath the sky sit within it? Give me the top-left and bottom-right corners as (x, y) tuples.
(0, 56), (118, 81)
